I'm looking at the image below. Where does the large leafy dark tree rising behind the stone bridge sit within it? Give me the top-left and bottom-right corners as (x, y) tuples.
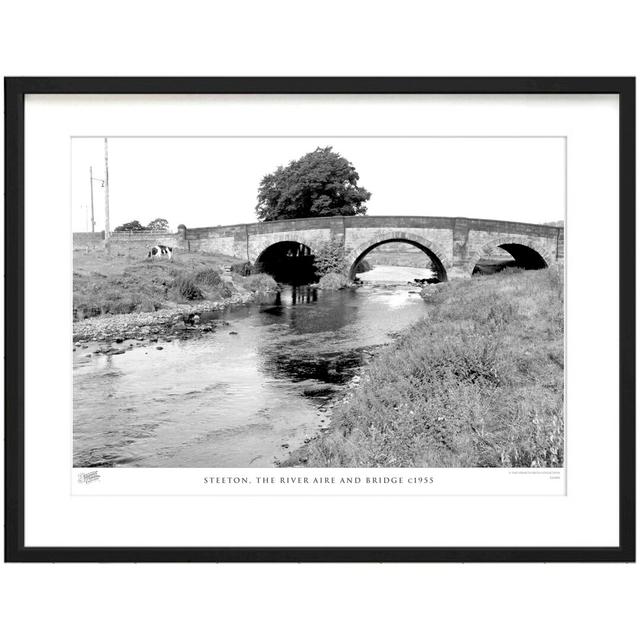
(256, 147), (371, 222)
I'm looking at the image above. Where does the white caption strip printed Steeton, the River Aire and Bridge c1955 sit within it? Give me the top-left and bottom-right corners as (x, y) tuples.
(71, 467), (566, 497)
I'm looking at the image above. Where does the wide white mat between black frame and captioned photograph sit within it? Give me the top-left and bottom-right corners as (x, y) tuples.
(25, 96), (618, 546)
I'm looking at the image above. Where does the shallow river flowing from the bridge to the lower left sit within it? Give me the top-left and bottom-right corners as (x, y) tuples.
(74, 268), (426, 467)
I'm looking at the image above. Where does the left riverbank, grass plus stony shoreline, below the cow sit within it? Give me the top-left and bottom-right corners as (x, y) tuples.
(73, 251), (277, 344)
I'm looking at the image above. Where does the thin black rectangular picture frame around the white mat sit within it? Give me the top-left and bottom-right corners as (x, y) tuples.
(4, 77), (636, 562)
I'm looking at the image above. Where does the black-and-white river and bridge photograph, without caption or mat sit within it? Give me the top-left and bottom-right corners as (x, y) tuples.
(70, 135), (564, 469)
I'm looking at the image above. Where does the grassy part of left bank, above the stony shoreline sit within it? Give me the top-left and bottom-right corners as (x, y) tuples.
(73, 251), (275, 320)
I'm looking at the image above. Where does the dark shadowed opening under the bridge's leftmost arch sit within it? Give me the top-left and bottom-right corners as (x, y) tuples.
(254, 240), (317, 285)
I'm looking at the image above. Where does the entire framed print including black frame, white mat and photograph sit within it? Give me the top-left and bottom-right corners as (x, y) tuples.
(6, 78), (634, 562)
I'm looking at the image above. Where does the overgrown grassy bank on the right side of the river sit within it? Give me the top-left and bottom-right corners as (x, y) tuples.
(302, 268), (564, 467)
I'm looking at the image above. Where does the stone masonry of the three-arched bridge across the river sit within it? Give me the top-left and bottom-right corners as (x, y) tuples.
(176, 216), (564, 279)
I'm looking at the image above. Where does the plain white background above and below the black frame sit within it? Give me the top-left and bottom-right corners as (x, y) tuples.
(0, 0), (640, 640)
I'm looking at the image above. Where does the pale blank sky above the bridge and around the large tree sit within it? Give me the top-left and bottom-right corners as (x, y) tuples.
(71, 137), (565, 231)
